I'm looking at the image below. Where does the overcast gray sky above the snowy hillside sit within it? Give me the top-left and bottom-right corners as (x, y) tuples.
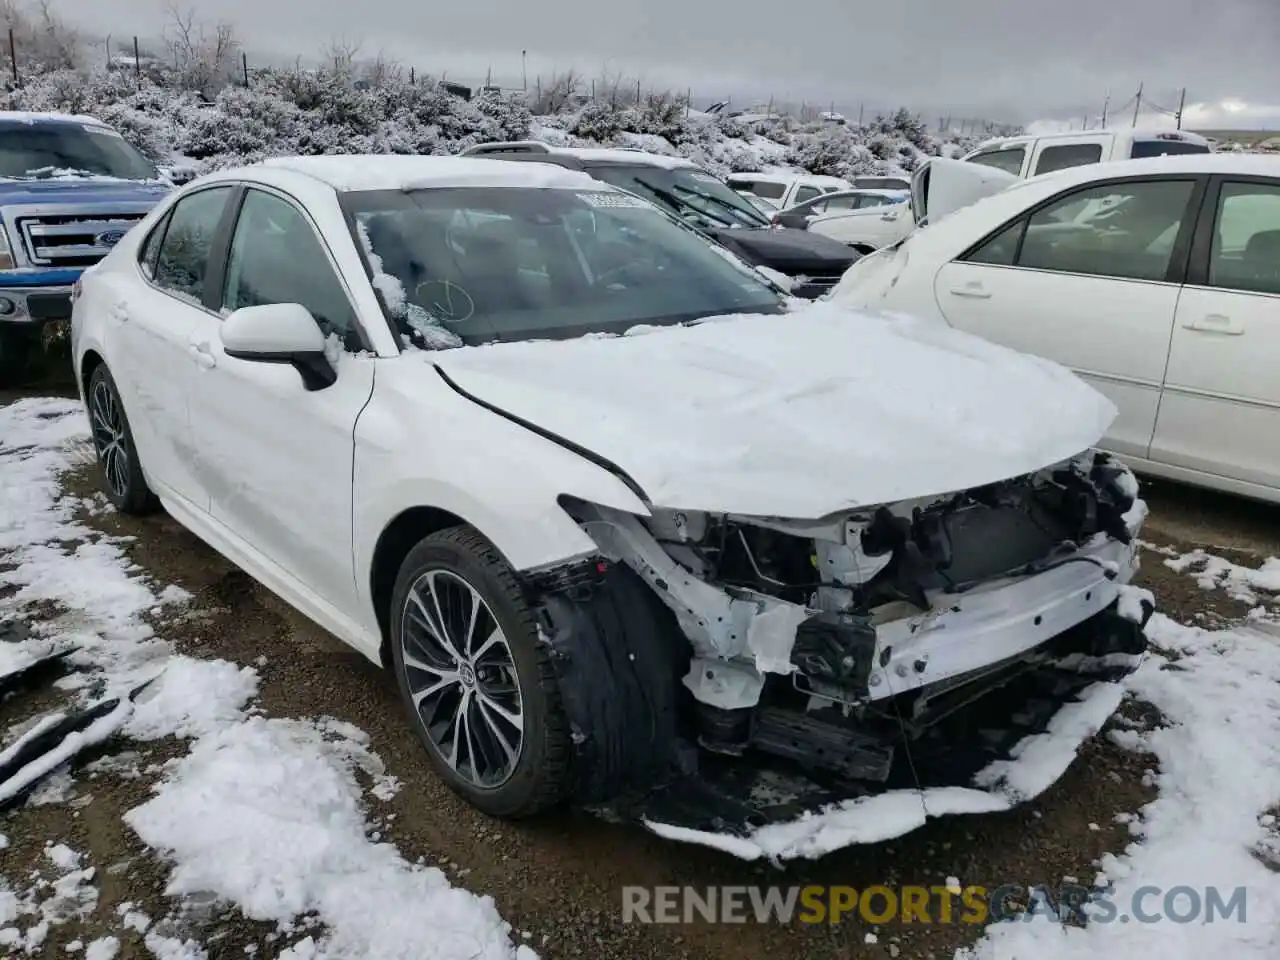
(55, 0), (1280, 127)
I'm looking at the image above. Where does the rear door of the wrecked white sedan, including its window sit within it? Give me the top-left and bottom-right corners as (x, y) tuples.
(105, 186), (233, 511)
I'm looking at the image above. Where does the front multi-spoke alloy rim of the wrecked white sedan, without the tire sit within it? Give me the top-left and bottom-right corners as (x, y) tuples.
(401, 570), (525, 790)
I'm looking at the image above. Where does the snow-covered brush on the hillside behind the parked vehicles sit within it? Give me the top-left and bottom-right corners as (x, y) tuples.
(0, 69), (977, 184)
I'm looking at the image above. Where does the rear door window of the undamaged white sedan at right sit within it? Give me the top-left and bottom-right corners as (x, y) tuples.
(964, 180), (1196, 280)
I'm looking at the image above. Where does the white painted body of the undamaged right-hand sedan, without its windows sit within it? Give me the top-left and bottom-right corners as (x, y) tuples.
(832, 154), (1280, 500)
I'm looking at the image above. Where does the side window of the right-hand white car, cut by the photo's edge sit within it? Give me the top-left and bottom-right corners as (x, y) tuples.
(1208, 182), (1280, 294)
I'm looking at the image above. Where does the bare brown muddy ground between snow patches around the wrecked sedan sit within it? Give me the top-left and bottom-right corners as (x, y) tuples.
(0, 378), (1280, 960)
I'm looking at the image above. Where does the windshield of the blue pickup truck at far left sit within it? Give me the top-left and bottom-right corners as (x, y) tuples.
(0, 122), (160, 180)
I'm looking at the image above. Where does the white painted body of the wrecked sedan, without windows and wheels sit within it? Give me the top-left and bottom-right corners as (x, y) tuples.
(72, 157), (1144, 834)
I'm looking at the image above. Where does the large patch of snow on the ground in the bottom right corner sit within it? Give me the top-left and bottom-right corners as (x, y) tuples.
(957, 614), (1280, 960)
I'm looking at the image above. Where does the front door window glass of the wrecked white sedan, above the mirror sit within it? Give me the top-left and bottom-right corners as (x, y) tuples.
(223, 189), (358, 348)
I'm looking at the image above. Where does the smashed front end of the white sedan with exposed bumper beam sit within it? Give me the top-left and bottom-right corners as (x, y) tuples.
(517, 452), (1152, 859)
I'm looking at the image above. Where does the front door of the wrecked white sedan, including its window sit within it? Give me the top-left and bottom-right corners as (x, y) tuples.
(184, 188), (376, 612)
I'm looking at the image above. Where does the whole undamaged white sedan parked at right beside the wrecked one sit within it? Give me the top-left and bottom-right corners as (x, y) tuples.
(833, 154), (1280, 502)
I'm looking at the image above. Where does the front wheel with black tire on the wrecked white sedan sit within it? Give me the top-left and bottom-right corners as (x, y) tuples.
(390, 526), (572, 819)
